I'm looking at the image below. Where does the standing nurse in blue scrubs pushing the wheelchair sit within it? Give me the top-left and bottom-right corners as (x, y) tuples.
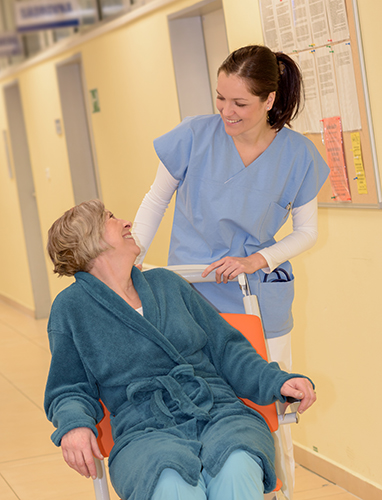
(134, 45), (329, 499)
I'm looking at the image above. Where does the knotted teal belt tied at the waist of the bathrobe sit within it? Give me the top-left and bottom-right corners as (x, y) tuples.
(126, 364), (214, 427)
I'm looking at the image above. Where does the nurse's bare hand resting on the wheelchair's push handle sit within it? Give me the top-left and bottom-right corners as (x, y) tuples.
(202, 253), (268, 283)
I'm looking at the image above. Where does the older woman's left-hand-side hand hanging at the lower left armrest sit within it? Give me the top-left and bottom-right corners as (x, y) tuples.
(61, 427), (103, 479)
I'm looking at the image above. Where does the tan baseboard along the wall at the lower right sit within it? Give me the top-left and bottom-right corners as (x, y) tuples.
(293, 443), (382, 500)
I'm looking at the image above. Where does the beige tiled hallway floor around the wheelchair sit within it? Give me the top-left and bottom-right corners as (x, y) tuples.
(0, 301), (356, 500)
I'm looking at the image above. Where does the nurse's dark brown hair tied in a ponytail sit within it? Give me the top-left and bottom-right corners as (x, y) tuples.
(218, 45), (303, 130)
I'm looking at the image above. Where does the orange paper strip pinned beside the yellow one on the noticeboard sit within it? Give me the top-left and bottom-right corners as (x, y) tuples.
(321, 116), (351, 201)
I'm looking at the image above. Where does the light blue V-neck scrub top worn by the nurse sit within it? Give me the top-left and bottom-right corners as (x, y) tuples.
(154, 115), (329, 338)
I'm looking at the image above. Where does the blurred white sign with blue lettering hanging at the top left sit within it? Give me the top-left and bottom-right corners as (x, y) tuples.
(15, 0), (80, 32)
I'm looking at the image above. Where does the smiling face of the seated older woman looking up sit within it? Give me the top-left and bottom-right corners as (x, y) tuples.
(103, 210), (140, 256)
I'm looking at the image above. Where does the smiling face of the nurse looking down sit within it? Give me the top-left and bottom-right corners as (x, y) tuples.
(216, 71), (275, 137)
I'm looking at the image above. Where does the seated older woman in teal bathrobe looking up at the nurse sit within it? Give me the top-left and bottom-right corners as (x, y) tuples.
(45, 200), (315, 500)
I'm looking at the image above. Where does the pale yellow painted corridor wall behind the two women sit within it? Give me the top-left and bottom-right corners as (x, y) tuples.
(0, 0), (382, 494)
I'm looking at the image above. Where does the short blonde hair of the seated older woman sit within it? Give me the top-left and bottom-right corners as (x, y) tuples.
(47, 200), (109, 276)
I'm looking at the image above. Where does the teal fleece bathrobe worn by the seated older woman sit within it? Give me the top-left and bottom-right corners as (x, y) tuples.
(45, 268), (308, 500)
